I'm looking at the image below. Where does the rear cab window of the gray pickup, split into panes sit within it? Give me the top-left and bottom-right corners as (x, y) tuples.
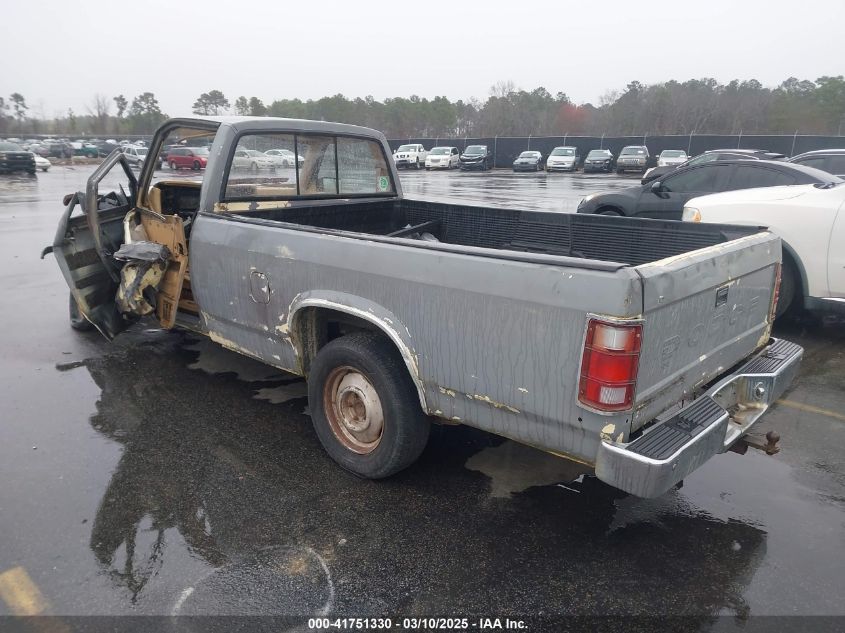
(222, 132), (396, 201)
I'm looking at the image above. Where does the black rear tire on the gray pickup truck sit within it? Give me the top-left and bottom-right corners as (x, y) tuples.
(308, 332), (430, 479)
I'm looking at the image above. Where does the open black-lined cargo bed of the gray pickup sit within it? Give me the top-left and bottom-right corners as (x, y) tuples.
(232, 199), (761, 266)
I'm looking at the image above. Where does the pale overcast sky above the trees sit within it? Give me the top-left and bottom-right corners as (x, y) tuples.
(0, 0), (845, 117)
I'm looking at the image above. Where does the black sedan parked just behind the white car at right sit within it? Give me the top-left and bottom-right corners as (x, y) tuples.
(578, 160), (843, 220)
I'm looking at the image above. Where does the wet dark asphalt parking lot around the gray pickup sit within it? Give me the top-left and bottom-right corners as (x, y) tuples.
(0, 167), (845, 630)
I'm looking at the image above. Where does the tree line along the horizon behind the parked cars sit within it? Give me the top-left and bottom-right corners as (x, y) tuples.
(0, 75), (845, 138)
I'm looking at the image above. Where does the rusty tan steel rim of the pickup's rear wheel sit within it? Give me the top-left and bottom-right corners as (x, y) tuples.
(323, 366), (384, 455)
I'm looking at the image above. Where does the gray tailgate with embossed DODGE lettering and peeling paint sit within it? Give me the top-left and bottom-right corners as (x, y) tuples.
(631, 231), (781, 431)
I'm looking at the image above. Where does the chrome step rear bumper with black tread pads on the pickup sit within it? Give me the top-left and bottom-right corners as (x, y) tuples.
(596, 339), (804, 497)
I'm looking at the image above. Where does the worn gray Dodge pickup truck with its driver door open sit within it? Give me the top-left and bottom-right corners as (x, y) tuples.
(45, 118), (802, 497)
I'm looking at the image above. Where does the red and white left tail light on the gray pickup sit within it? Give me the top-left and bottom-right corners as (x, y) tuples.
(578, 319), (643, 411)
